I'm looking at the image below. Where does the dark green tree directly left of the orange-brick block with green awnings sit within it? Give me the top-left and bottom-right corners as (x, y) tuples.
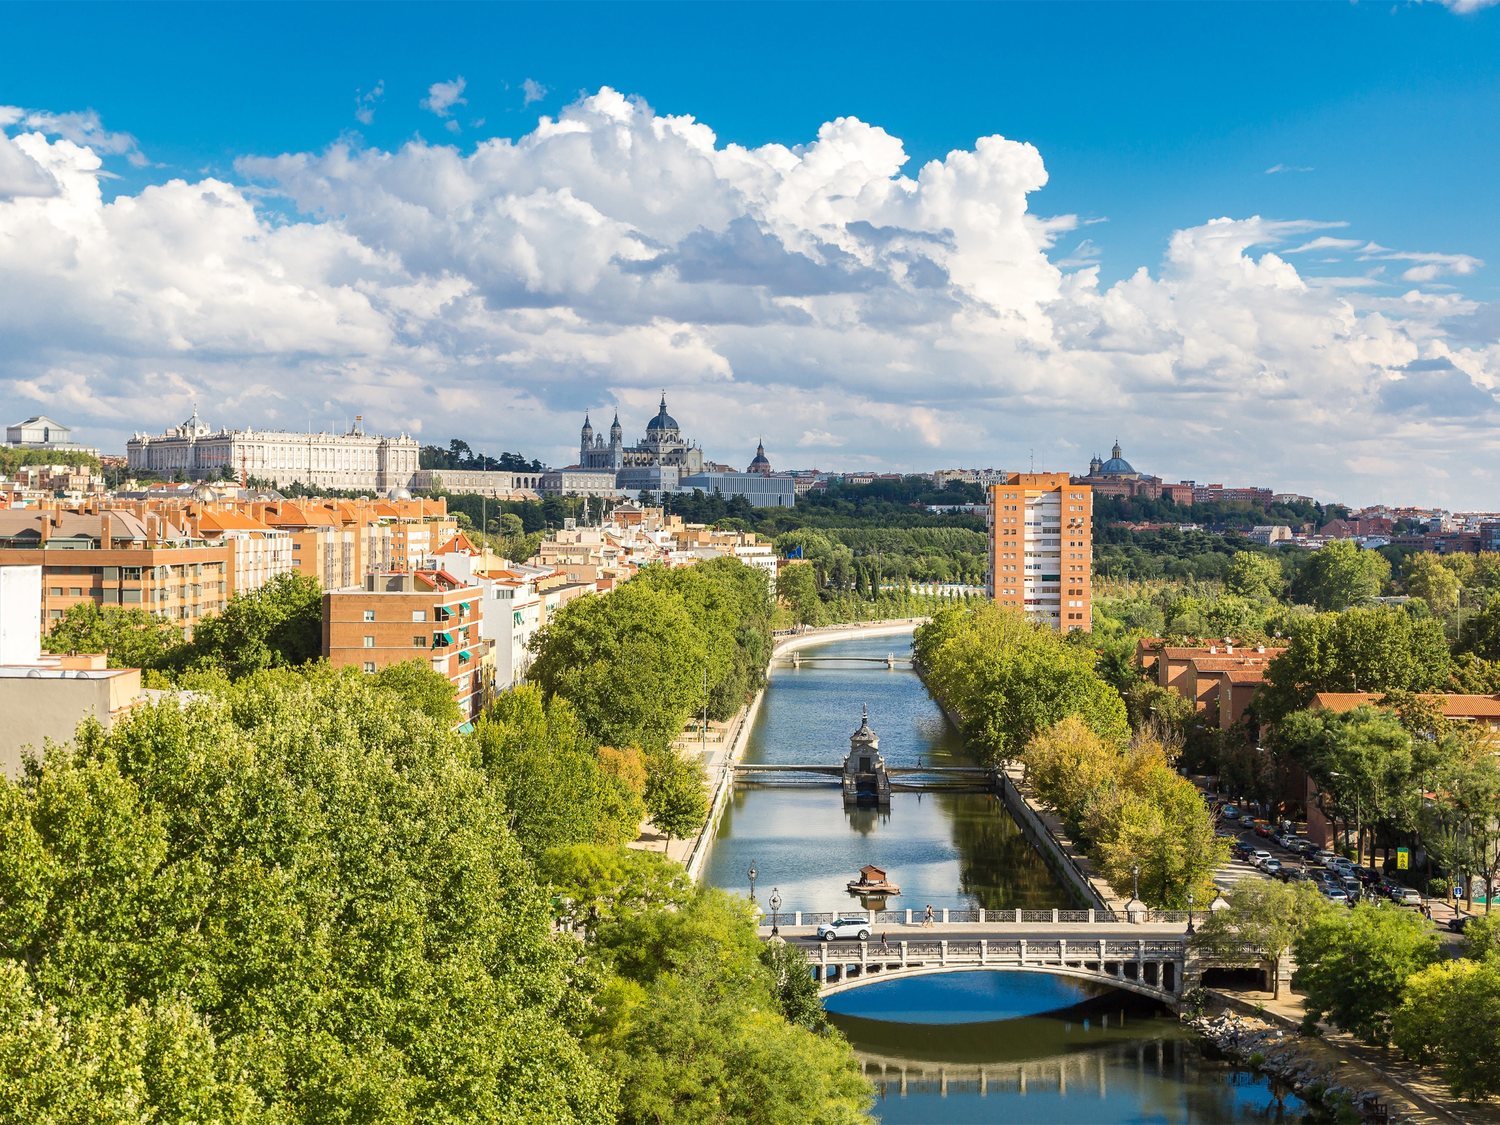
(186, 575), (323, 680)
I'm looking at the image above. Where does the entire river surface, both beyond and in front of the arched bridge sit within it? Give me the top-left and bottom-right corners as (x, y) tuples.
(705, 636), (1305, 1125)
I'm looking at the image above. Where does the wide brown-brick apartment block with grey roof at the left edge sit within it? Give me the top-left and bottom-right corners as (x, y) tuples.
(0, 509), (234, 633)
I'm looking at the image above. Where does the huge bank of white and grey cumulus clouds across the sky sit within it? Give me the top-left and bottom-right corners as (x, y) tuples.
(0, 89), (1500, 503)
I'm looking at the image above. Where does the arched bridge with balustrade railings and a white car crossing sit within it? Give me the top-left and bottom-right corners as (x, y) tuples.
(761, 911), (1199, 1004)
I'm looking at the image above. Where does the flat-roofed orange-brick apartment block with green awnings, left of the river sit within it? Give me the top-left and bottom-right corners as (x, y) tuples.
(323, 570), (492, 723)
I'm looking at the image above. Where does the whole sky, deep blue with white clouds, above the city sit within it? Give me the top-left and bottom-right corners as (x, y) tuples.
(0, 5), (1500, 509)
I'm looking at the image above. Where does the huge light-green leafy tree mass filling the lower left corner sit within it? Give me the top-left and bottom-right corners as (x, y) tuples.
(0, 666), (617, 1122)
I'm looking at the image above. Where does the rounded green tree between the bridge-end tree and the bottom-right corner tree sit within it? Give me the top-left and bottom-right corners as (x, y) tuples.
(1292, 903), (1437, 1043)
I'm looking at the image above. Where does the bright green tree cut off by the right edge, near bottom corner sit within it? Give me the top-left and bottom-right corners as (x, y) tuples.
(1391, 959), (1500, 1101)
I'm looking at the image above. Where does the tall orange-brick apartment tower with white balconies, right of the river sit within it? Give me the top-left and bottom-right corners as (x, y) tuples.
(989, 473), (1094, 633)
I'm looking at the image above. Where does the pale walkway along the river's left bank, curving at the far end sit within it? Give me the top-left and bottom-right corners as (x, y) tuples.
(654, 618), (927, 881)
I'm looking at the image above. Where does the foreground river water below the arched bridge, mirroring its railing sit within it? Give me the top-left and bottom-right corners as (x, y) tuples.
(828, 972), (1305, 1122)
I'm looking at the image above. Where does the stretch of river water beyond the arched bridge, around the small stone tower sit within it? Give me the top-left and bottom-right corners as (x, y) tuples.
(707, 638), (1074, 912)
